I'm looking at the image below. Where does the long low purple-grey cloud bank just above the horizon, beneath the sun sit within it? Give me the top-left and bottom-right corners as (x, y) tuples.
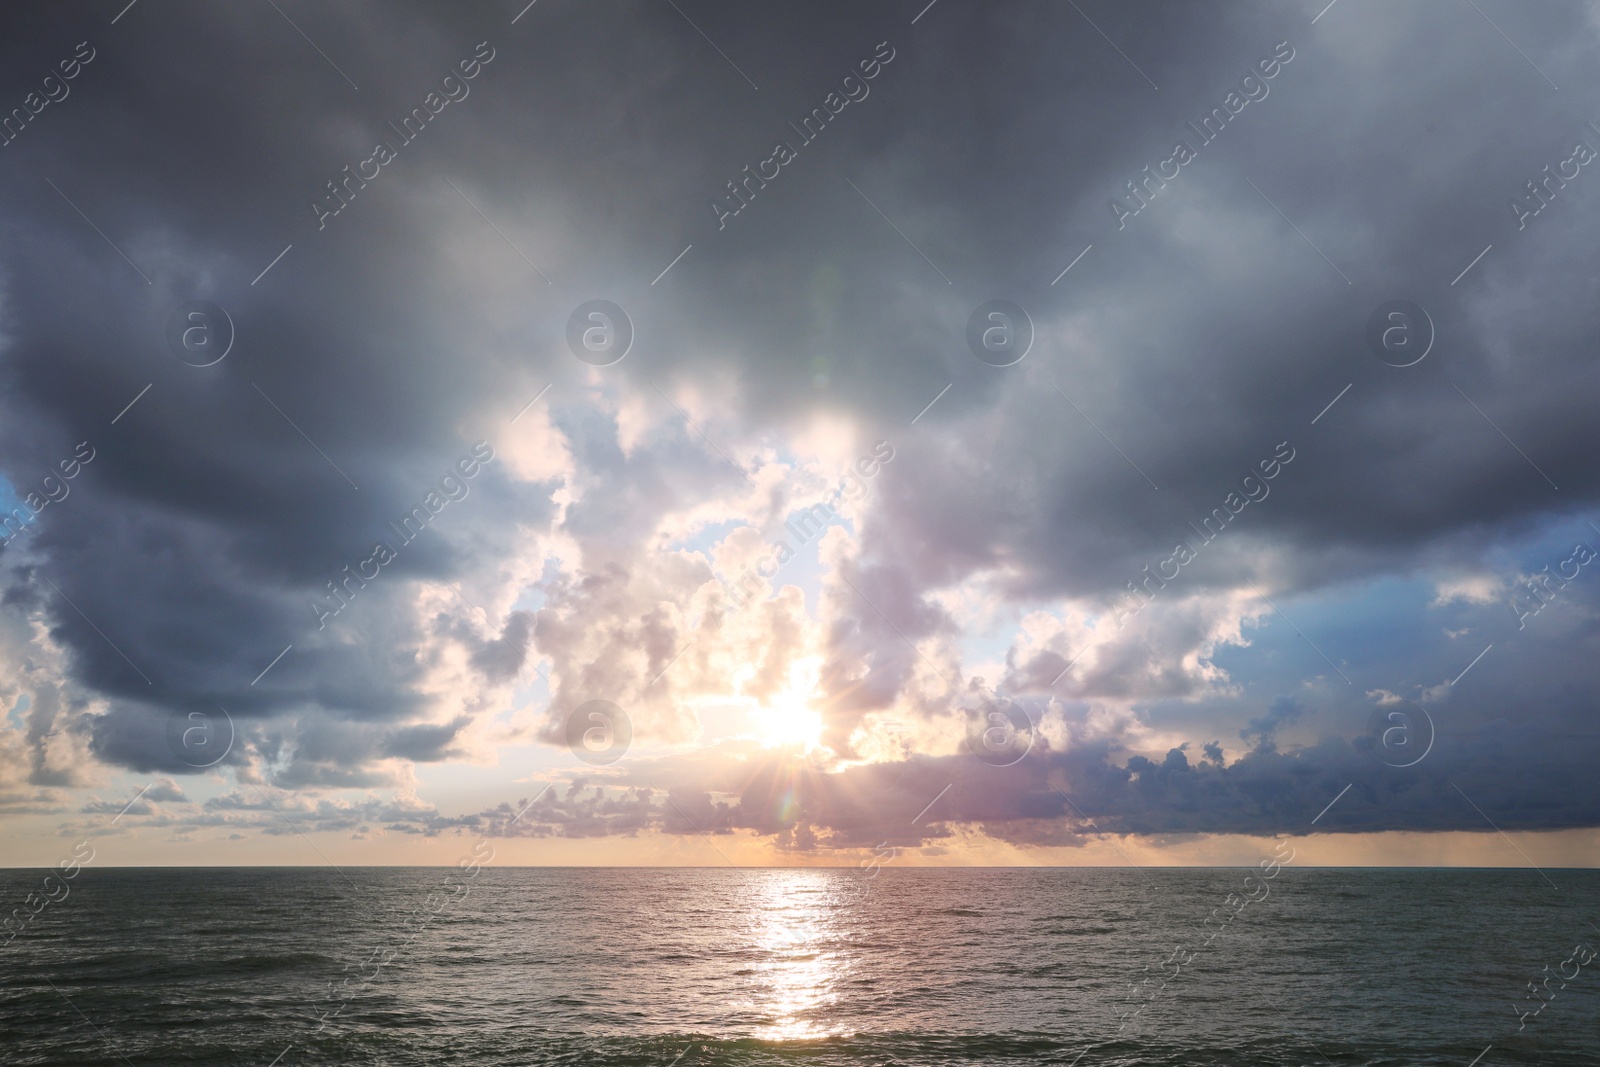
(360, 720), (1600, 853)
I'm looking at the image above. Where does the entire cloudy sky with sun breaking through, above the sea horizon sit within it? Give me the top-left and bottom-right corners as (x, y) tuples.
(0, 0), (1600, 869)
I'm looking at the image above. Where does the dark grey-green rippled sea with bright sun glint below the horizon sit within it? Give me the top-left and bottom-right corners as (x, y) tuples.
(0, 864), (1600, 1067)
